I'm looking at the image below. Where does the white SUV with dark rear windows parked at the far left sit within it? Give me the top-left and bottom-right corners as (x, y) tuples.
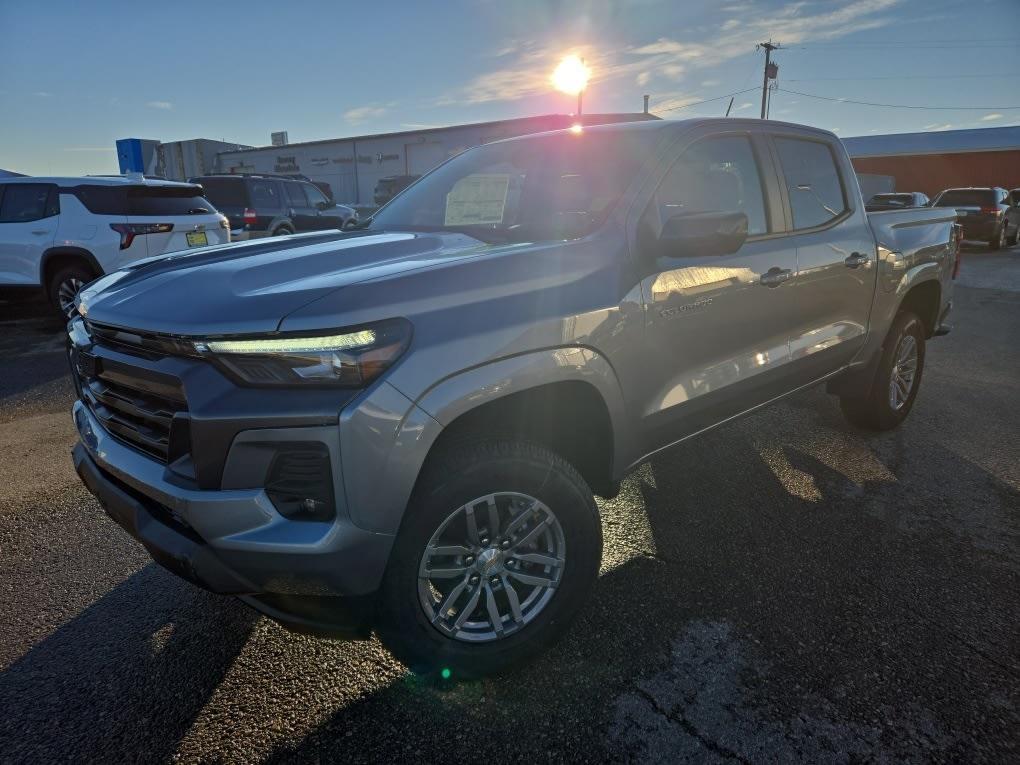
(0, 175), (231, 315)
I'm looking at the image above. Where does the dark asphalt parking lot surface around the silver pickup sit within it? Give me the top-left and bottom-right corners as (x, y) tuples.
(0, 243), (1020, 763)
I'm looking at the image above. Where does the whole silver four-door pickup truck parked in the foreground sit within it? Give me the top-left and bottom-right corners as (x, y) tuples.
(68, 119), (959, 676)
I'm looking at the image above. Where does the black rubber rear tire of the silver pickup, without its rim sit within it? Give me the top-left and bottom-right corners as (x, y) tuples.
(839, 311), (925, 430)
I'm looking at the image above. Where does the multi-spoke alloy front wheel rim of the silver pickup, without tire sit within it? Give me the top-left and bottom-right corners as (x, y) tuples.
(418, 492), (566, 643)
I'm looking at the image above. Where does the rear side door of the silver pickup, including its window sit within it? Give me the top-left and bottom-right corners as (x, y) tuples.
(770, 134), (878, 384)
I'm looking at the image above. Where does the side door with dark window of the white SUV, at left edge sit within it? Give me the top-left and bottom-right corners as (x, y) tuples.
(0, 184), (60, 285)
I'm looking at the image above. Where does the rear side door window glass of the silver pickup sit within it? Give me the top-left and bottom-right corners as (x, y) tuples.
(775, 138), (847, 228)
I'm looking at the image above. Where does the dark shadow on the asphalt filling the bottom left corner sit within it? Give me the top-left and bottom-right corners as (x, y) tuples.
(0, 564), (257, 762)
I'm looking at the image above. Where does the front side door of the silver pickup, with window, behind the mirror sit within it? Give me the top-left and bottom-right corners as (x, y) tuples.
(639, 131), (797, 452)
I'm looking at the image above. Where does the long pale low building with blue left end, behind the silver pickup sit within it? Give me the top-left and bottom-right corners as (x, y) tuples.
(117, 112), (659, 205)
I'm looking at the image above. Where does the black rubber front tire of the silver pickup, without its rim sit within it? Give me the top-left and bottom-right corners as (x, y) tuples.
(376, 440), (602, 679)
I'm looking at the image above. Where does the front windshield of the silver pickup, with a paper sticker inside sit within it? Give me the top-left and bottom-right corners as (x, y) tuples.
(370, 131), (654, 243)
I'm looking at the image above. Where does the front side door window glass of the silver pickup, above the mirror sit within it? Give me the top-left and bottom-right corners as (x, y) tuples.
(645, 136), (768, 236)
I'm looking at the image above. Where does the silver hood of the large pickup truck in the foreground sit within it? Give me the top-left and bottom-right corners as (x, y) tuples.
(79, 232), (489, 336)
